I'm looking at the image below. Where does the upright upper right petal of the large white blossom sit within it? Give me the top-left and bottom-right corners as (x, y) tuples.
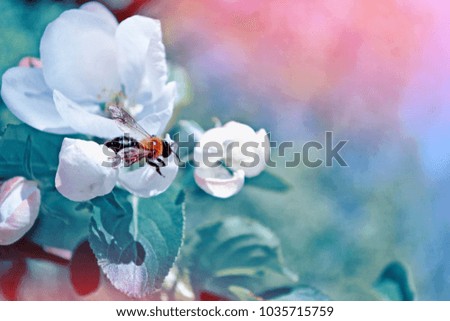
(116, 16), (167, 101)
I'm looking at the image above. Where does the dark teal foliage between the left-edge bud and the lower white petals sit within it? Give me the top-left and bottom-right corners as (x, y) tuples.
(0, 124), (91, 250)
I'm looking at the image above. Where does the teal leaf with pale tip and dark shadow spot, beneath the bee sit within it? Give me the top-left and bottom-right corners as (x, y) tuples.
(89, 187), (184, 297)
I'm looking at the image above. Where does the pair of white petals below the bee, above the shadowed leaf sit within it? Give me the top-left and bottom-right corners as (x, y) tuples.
(55, 136), (178, 201)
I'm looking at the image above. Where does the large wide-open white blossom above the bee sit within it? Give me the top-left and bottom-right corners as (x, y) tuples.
(1, 2), (175, 138)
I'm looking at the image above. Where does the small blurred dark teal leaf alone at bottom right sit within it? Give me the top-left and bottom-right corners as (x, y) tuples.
(374, 262), (414, 301)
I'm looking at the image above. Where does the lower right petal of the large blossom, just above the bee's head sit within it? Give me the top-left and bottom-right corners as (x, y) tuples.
(138, 82), (176, 136)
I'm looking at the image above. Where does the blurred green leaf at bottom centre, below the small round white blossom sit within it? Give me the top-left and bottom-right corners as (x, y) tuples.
(181, 217), (297, 299)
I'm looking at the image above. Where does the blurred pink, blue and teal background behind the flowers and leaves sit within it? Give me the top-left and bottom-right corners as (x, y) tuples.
(0, 0), (450, 300)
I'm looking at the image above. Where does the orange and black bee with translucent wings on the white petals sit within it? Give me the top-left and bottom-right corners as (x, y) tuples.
(105, 106), (180, 177)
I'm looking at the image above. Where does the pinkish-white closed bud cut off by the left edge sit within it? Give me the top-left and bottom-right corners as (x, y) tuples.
(0, 177), (41, 245)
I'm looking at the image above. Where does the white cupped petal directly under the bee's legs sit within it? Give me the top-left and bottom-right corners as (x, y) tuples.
(119, 154), (178, 197)
